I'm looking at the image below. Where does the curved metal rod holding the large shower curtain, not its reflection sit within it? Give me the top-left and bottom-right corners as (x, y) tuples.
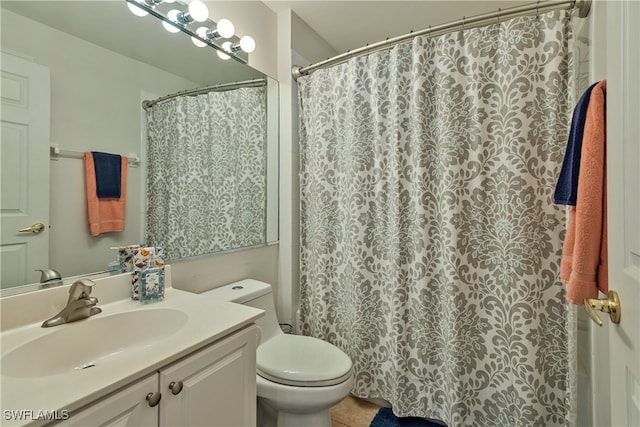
(291, 0), (591, 80)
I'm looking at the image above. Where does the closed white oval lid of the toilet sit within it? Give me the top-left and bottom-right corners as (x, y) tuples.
(256, 334), (351, 387)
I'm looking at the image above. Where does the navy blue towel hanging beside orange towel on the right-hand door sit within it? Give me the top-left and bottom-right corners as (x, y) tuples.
(553, 83), (598, 206)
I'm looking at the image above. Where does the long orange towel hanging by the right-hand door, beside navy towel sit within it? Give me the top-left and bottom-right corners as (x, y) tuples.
(560, 80), (609, 305)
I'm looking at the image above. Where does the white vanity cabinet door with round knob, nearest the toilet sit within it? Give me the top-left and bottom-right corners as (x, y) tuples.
(160, 325), (257, 427)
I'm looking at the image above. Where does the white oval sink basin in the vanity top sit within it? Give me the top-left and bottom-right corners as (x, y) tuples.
(1, 308), (188, 378)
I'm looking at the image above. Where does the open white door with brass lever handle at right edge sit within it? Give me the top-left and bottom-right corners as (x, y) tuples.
(595, 0), (640, 426)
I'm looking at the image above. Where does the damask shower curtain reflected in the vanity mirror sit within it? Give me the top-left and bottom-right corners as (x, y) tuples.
(146, 86), (266, 259)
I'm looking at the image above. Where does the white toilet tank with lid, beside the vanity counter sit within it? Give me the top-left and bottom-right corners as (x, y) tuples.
(200, 279), (283, 344)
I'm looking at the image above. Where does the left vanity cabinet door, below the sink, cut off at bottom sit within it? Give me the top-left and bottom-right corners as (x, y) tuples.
(59, 374), (158, 427)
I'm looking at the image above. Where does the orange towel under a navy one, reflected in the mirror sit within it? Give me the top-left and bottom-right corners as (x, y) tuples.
(84, 152), (128, 236)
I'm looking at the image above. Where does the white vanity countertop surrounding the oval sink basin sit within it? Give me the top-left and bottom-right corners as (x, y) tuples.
(0, 288), (263, 426)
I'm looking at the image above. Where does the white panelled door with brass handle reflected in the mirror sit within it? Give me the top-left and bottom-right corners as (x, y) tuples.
(0, 52), (50, 289)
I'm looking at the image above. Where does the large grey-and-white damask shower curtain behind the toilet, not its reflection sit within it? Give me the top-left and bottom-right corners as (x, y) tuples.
(298, 11), (575, 426)
